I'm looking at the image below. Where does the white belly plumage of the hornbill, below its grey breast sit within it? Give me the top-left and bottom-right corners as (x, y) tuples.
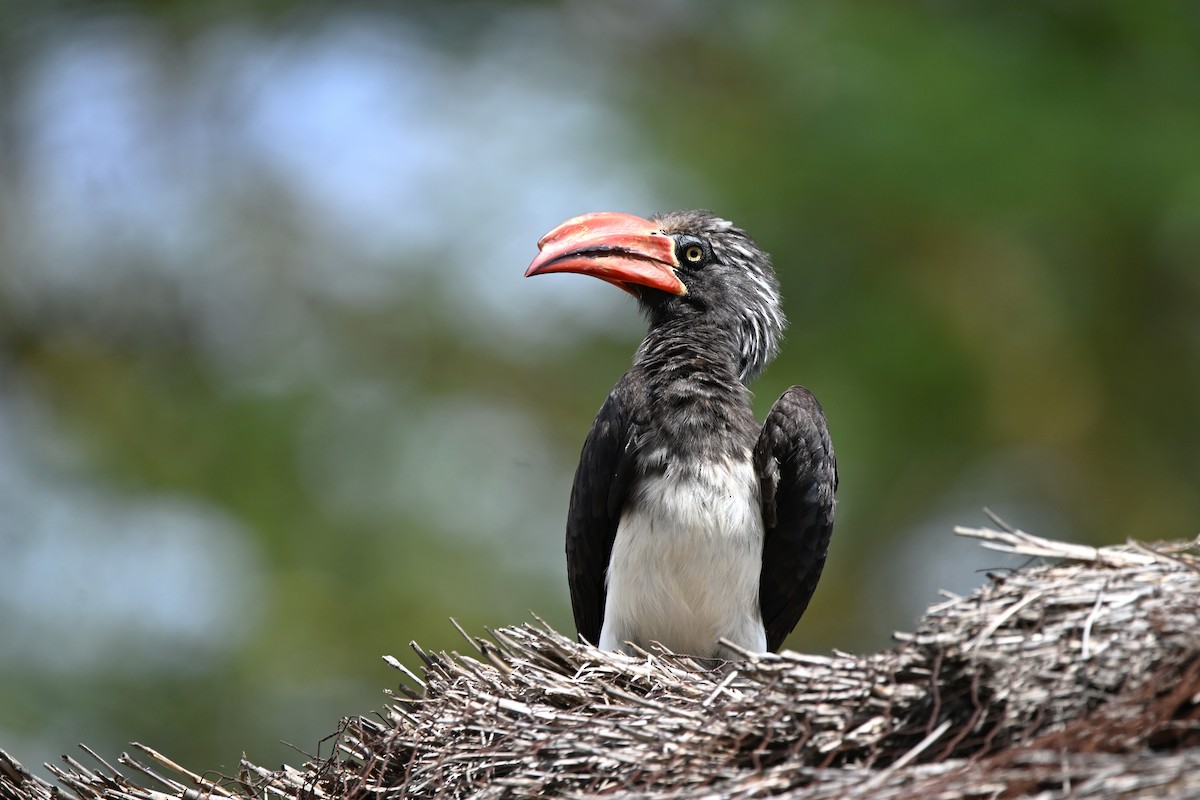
(600, 459), (767, 657)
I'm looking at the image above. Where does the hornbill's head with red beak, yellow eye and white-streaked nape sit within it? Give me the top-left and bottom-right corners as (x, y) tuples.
(526, 211), (787, 383)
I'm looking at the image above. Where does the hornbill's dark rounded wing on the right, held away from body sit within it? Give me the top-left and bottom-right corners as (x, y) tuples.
(754, 386), (838, 652)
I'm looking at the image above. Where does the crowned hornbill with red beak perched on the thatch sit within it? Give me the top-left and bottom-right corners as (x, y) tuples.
(526, 211), (838, 658)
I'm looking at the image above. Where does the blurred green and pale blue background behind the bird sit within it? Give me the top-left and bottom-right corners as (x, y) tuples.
(0, 0), (1200, 772)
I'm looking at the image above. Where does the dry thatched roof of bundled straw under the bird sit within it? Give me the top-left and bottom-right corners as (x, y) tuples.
(0, 529), (1200, 800)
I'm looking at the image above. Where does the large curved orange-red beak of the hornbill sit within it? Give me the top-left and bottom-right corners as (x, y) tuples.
(526, 211), (688, 295)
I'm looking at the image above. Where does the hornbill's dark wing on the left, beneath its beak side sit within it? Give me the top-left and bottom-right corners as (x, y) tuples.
(566, 375), (635, 644)
